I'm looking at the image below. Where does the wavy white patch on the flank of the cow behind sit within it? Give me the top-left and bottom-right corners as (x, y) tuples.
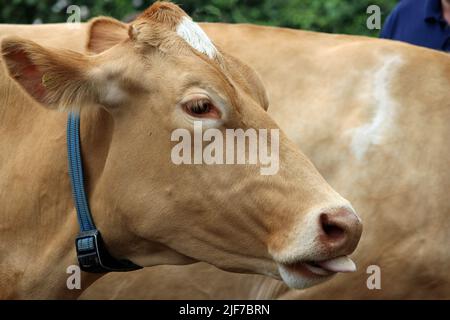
(351, 56), (402, 160)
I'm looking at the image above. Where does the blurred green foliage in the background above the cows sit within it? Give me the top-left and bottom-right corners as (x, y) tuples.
(0, 0), (397, 36)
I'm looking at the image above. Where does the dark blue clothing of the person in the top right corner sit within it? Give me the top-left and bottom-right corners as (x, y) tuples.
(380, 0), (450, 52)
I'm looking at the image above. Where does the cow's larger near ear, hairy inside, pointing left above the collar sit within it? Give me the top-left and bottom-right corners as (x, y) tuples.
(1, 38), (96, 109)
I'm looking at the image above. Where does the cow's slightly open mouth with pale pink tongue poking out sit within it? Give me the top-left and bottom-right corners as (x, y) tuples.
(278, 256), (356, 289)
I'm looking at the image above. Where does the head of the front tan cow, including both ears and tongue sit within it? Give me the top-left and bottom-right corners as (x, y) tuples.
(2, 2), (361, 288)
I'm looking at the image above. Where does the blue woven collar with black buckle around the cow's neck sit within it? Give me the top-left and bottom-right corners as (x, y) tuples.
(67, 112), (142, 273)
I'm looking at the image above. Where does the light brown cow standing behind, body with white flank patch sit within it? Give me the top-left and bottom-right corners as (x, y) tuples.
(78, 20), (450, 299)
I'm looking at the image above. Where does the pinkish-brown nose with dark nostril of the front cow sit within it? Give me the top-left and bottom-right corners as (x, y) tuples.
(319, 208), (362, 256)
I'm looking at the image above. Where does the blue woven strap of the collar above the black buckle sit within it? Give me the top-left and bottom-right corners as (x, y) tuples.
(67, 112), (96, 232)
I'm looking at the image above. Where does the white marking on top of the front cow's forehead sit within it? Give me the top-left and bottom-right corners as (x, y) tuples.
(177, 17), (217, 59)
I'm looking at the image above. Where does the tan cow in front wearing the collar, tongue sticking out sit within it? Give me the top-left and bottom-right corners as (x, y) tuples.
(0, 2), (362, 299)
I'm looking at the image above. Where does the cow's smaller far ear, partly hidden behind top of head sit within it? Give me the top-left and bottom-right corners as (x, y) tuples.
(86, 17), (129, 54)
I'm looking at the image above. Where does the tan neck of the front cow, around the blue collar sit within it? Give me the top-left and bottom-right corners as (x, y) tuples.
(0, 99), (112, 299)
